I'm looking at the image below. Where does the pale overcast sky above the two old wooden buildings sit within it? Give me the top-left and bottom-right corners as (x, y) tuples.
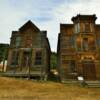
(0, 0), (100, 51)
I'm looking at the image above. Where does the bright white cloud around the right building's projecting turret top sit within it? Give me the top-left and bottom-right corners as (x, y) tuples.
(54, 0), (100, 23)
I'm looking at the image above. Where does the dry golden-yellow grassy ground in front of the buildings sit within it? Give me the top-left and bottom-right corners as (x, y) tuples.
(0, 77), (100, 100)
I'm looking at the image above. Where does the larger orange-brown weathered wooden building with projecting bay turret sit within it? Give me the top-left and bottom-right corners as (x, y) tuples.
(57, 14), (100, 82)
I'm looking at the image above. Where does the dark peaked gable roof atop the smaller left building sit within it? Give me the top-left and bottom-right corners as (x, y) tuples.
(19, 20), (40, 31)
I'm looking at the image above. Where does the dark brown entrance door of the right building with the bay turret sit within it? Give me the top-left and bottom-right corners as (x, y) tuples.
(83, 61), (96, 80)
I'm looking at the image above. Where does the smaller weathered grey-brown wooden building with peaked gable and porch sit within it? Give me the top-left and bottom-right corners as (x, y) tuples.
(6, 21), (51, 78)
